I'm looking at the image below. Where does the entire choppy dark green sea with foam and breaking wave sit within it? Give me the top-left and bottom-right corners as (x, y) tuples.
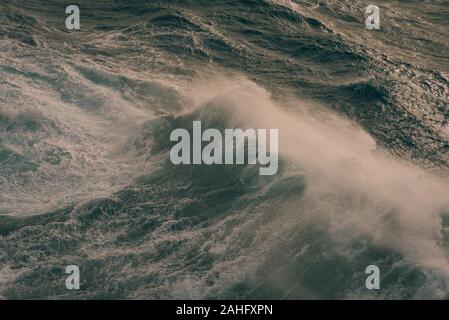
(0, 0), (449, 299)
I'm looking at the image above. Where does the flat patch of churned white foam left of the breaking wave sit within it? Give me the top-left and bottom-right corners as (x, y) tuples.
(0, 66), (160, 215)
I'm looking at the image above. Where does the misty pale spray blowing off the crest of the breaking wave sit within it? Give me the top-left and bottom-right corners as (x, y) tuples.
(184, 78), (449, 275)
